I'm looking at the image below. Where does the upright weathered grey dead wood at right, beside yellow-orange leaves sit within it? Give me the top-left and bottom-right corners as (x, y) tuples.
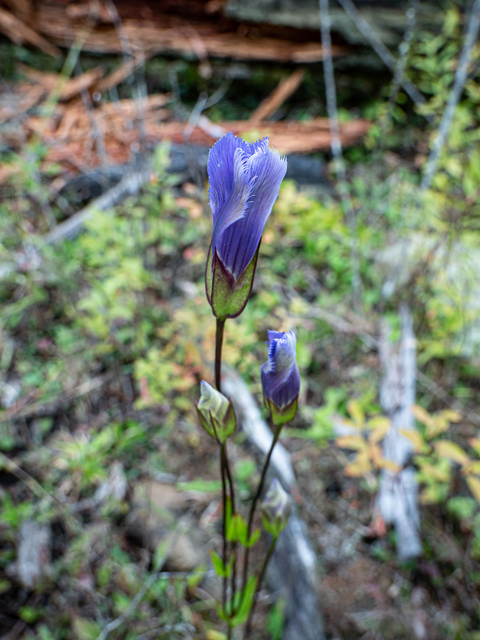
(377, 307), (422, 560)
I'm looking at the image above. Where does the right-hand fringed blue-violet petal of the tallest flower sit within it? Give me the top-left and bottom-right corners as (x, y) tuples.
(217, 149), (287, 279)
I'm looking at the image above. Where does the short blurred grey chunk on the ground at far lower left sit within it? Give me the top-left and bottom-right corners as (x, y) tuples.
(16, 520), (52, 589)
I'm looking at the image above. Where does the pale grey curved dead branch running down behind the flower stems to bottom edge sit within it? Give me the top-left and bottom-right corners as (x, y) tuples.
(222, 369), (325, 640)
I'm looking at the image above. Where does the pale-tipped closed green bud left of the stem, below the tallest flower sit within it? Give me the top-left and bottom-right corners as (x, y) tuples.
(197, 380), (235, 443)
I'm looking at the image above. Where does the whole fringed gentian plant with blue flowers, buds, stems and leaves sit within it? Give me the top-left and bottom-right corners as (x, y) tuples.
(197, 133), (300, 639)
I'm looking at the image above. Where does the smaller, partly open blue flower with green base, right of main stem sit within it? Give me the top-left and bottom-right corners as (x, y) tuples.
(261, 331), (300, 425)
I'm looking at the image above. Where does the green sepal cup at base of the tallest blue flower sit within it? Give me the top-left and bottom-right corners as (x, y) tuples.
(205, 243), (260, 320)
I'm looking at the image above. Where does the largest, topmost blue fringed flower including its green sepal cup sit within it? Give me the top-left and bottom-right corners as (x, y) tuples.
(206, 132), (287, 318)
